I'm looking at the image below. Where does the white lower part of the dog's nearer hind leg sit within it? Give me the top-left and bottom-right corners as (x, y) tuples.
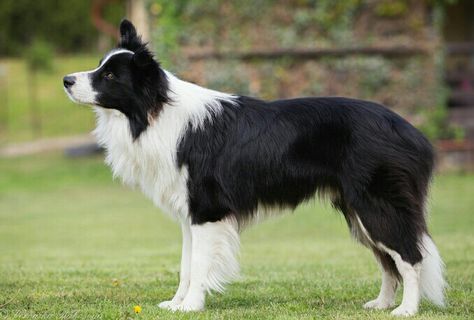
(377, 243), (421, 317)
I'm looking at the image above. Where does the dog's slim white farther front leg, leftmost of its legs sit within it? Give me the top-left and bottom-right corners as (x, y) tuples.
(158, 219), (192, 309)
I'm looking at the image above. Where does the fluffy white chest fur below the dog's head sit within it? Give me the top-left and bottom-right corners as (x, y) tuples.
(94, 108), (188, 218)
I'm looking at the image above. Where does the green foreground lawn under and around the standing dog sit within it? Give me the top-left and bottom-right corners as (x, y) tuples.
(0, 154), (474, 319)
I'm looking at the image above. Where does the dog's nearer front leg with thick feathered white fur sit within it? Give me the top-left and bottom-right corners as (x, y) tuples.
(170, 219), (239, 311)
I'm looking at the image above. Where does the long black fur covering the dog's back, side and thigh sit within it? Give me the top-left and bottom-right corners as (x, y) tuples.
(178, 97), (434, 274)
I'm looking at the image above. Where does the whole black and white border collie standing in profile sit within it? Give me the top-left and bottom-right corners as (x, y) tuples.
(64, 20), (445, 316)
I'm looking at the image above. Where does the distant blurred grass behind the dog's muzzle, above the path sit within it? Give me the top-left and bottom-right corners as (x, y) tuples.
(0, 56), (100, 143)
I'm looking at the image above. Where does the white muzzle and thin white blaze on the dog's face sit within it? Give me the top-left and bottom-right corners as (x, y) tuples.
(65, 49), (133, 104)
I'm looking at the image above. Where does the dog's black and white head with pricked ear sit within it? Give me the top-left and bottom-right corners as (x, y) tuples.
(63, 20), (169, 139)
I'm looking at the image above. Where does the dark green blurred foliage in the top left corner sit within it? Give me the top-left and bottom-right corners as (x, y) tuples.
(0, 0), (125, 56)
